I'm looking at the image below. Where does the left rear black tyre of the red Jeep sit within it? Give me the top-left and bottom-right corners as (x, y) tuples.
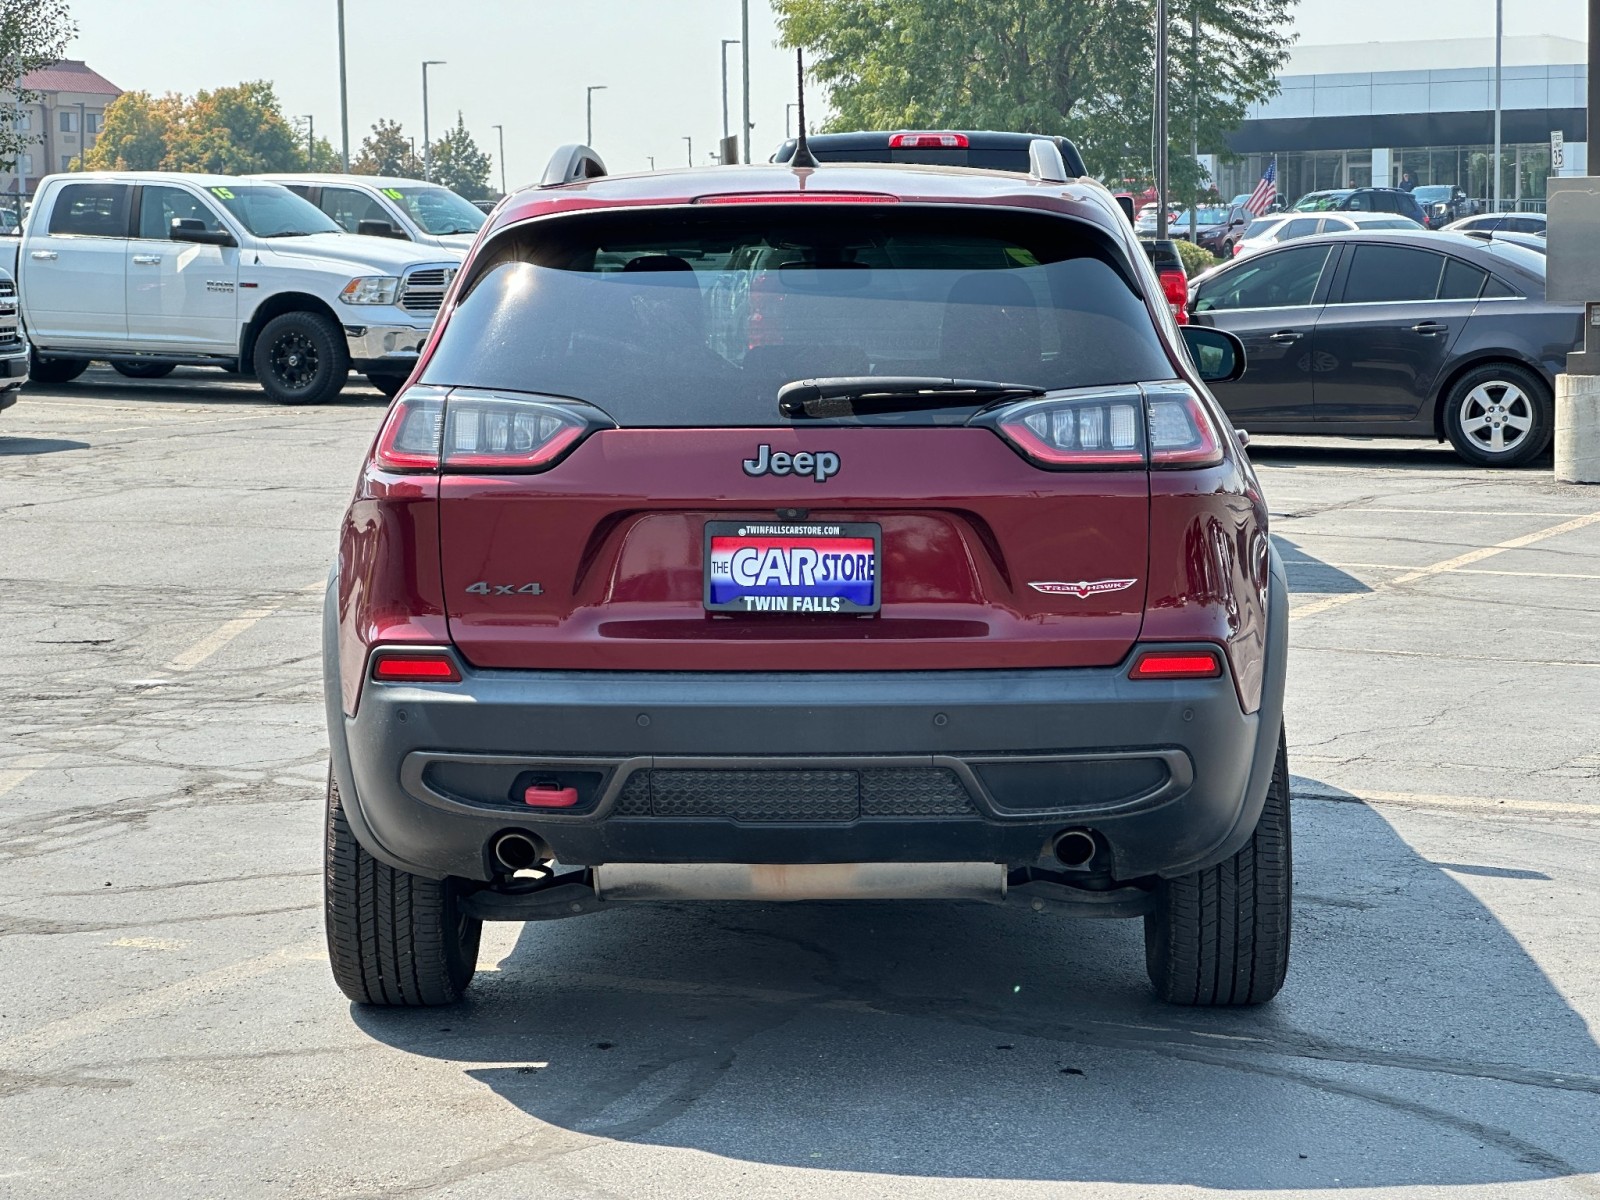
(323, 773), (483, 1008)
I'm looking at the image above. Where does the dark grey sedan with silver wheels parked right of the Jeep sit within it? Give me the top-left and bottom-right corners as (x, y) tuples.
(1189, 230), (1582, 467)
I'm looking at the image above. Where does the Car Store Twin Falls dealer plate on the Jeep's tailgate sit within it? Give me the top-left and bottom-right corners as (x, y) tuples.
(706, 522), (883, 614)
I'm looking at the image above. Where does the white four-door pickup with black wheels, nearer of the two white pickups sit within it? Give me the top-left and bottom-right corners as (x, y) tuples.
(0, 171), (461, 405)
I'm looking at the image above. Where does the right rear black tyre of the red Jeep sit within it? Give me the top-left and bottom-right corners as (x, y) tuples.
(1144, 733), (1293, 1006)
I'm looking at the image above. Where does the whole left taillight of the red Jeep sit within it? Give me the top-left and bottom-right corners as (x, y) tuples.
(374, 387), (610, 472)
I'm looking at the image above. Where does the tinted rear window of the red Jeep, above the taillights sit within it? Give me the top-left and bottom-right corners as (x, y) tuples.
(422, 205), (1173, 426)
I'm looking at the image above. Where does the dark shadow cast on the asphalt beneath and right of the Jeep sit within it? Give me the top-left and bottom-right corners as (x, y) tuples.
(352, 779), (1600, 1190)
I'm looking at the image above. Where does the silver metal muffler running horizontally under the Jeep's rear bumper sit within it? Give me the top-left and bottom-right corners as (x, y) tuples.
(594, 862), (1006, 904)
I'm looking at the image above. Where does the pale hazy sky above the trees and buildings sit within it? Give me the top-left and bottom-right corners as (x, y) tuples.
(59, 0), (1586, 187)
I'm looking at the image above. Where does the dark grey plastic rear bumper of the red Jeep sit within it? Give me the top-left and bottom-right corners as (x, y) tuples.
(325, 560), (1286, 882)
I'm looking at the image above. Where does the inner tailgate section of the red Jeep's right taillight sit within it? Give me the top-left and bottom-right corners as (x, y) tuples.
(982, 389), (1144, 469)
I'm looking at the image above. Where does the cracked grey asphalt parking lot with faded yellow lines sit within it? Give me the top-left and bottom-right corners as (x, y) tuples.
(0, 368), (1600, 1200)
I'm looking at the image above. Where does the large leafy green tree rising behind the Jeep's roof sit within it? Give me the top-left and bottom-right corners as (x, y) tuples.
(773, 0), (1293, 194)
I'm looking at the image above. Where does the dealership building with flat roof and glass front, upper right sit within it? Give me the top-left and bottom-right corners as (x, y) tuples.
(1206, 37), (1589, 210)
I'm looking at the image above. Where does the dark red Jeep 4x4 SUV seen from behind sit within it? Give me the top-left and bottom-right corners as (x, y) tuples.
(325, 148), (1290, 1005)
